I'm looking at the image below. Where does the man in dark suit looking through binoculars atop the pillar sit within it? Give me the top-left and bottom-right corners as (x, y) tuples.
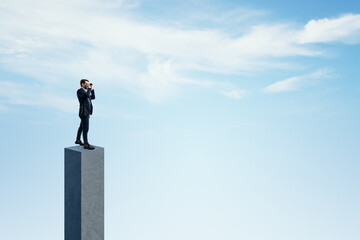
(75, 79), (95, 150)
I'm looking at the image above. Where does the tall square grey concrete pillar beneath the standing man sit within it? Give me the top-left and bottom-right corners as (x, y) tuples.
(65, 146), (104, 240)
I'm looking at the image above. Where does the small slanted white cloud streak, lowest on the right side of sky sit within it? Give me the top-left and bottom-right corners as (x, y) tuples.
(262, 70), (330, 93)
